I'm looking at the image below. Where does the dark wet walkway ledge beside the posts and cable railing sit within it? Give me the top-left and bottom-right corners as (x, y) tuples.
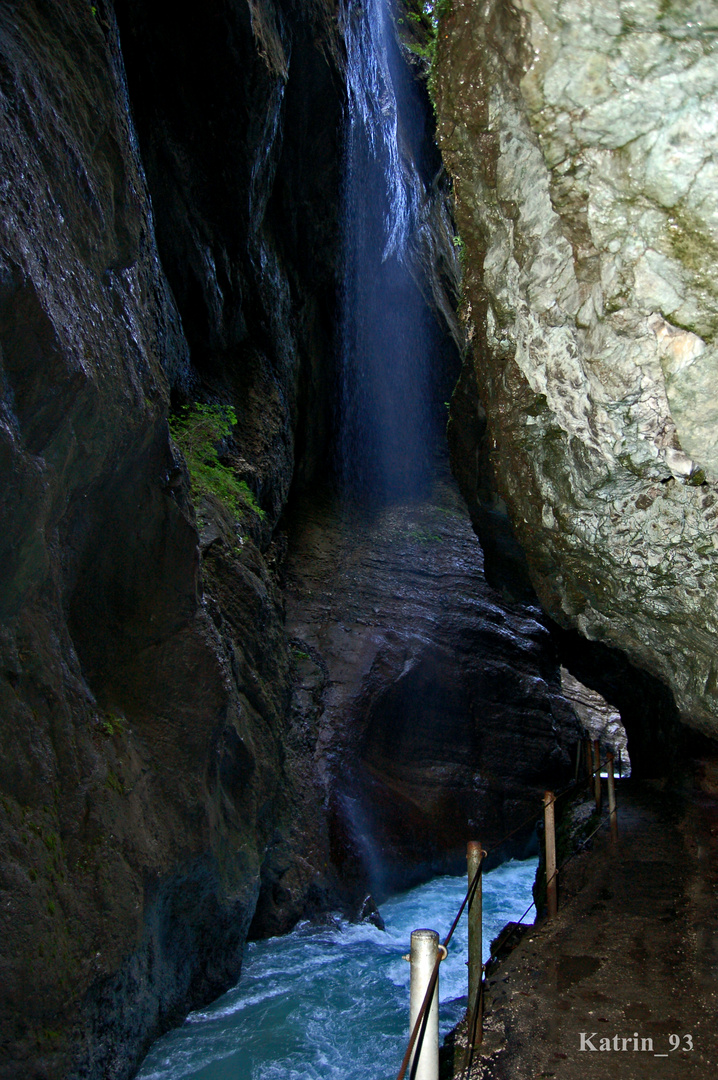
(442, 780), (718, 1080)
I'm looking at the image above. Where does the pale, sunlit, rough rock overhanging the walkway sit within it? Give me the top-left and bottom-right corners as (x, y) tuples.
(434, 0), (718, 732)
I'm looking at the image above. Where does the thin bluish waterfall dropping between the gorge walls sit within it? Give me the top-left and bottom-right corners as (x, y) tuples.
(337, 0), (438, 502)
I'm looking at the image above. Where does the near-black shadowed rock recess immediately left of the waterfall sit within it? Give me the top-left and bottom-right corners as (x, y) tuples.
(116, 0), (343, 509)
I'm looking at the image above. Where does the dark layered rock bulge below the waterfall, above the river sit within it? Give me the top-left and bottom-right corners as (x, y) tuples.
(249, 478), (579, 933)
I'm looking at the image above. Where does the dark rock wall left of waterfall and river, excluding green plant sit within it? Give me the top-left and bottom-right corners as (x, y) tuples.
(0, 0), (341, 1080)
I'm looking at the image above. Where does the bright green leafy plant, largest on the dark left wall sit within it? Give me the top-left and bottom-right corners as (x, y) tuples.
(170, 402), (265, 518)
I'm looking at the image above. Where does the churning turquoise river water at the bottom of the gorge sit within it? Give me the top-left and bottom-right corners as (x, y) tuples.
(139, 859), (538, 1080)
